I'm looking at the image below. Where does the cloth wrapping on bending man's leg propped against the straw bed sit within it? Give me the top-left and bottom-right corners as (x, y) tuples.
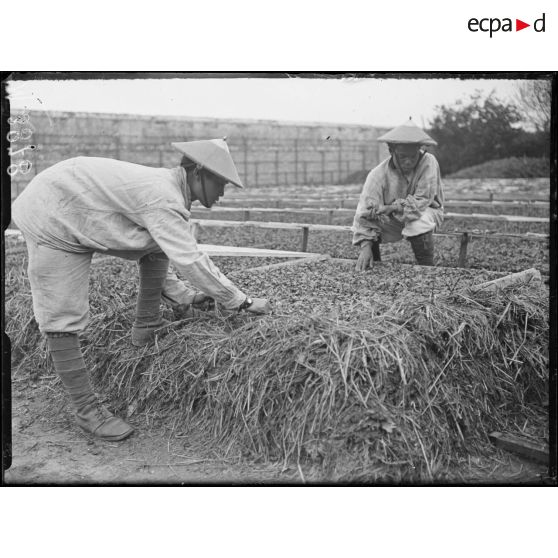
(134, 252), (169, 328)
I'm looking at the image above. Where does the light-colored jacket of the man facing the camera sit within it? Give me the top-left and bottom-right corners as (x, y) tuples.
(353, 153), (444, 245)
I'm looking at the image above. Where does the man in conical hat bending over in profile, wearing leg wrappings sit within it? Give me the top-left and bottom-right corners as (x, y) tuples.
(12, 140), (271, 441)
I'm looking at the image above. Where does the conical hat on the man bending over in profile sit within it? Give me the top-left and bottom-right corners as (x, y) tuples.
(172, 139), (244, 188)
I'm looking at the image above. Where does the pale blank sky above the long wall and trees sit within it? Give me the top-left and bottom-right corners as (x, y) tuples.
(8, 77), (528, 127)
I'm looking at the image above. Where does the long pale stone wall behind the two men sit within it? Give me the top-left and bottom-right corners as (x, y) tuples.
(7, 111), (387, 200)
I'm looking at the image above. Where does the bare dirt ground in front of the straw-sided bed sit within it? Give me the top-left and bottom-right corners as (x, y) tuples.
(3, 372), (547, 485)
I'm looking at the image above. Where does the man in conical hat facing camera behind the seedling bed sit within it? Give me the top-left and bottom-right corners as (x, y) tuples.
(353, 118), (444, 271)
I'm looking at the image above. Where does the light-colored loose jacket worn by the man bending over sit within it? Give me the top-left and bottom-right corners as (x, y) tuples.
(12, 157), (246, 308)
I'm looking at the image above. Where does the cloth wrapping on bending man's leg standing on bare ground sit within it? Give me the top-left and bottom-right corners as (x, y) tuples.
(47, 333), (95, 410)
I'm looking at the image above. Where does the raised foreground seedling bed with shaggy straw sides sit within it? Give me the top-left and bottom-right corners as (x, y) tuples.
(6, 252), (548, 482)
